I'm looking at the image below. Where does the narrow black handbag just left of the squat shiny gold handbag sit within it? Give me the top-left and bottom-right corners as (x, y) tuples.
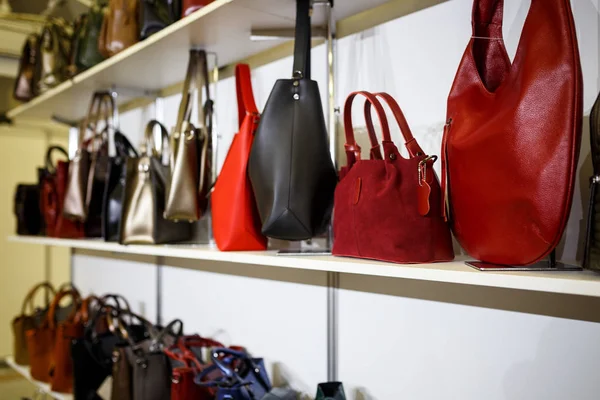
(102, 131), (138, 242)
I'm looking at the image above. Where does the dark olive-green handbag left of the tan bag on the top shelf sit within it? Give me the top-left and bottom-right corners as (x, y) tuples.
(75, 1), (108, 70)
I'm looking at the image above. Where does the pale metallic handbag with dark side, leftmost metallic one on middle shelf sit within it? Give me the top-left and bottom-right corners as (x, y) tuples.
(63, 93), (110, 237)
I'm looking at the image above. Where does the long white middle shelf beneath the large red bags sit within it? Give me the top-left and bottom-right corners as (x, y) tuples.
(9, 236), (600, 297)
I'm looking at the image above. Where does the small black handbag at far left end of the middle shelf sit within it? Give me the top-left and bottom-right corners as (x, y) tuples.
(14, 184), (43, 235)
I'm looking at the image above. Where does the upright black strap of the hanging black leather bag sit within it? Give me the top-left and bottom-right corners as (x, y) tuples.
(292, 0), (311, 79)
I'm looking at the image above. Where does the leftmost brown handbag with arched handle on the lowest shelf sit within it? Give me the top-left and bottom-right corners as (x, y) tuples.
(12, 282), (56, 365)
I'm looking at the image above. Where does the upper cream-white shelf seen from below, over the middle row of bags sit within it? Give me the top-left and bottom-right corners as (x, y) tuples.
(7, 0), (389, 120)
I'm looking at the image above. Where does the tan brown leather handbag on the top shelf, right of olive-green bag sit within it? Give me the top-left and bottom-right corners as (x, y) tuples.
(98, 0), (140, 57)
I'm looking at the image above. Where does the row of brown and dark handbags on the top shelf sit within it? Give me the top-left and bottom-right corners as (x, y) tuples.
(13, 0), (214, 101)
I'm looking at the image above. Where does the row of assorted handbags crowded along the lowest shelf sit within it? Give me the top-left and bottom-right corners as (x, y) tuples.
(12, 282), (345, 400)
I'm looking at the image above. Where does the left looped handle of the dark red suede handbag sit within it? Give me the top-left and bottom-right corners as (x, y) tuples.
(344, 91), (392, 167)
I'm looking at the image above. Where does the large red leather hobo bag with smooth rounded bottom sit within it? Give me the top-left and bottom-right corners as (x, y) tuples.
(442, 0), (583, 265)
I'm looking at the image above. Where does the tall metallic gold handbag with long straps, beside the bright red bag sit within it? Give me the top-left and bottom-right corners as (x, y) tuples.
(165, 50), (213, 221)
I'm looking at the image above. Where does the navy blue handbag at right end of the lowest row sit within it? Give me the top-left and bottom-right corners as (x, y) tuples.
(194, 348), (271, 400)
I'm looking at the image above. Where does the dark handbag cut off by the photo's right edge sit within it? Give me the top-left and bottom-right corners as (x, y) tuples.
(583, 94), (600, 271)
